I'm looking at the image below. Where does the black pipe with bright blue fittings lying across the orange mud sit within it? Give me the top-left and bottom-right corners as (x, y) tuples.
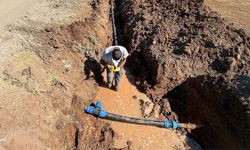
(85, 101), (180, 129)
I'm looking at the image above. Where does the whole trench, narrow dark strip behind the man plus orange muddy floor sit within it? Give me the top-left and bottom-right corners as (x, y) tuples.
(91, 1), (199, 149)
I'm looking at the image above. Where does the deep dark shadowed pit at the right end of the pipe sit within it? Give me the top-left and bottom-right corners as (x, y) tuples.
(165, 76), (250, 149)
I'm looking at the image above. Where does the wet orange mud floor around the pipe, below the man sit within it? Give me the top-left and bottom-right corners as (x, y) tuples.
(95, 70), (189, 150)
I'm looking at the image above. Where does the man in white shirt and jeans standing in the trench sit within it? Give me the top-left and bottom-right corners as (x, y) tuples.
(100, 46), (128, 91)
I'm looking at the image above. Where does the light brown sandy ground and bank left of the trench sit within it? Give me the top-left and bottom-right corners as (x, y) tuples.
(0, 0), (114, 149)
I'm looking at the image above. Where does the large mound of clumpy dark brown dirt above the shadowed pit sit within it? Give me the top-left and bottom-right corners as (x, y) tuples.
(121, 0), (250, 92)
